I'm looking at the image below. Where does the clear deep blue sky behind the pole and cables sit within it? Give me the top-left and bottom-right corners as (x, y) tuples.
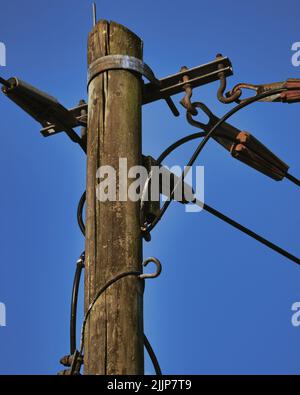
(0, 0), (300, 374)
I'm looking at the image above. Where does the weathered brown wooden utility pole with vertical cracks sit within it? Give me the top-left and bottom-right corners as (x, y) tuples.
(84, 21), (144, 375)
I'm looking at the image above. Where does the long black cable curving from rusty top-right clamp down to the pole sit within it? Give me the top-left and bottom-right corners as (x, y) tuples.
(146, 88), (288, 233)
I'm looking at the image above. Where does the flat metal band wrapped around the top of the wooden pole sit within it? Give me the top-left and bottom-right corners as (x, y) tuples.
(88, 55), (159, 85)
